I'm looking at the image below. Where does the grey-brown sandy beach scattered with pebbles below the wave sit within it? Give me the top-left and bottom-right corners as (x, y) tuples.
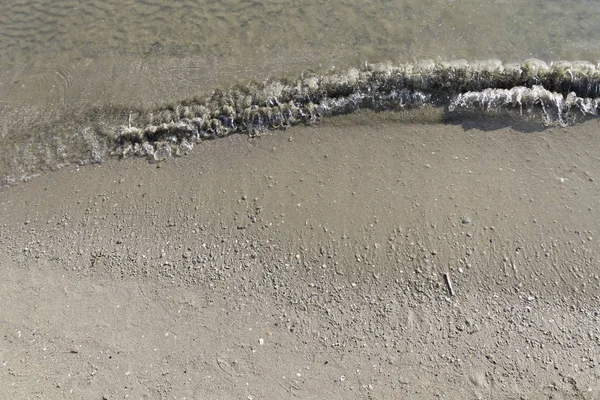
(0, 114), (600, 399)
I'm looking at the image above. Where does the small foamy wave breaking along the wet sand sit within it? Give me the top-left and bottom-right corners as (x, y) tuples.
(109, 59), (600, 160)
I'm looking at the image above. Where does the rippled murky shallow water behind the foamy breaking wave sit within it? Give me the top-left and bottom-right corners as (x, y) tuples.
(0, 0), (600, 184)
